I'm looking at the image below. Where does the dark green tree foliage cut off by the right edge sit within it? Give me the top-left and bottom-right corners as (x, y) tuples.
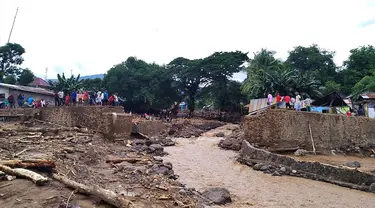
(338, 45), (375, 94)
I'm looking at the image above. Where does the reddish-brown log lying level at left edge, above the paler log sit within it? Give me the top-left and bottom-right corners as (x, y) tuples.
(0, 159), (56, 168)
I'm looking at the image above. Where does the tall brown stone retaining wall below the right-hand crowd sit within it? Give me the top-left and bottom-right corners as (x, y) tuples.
(244, 110), (375, 152)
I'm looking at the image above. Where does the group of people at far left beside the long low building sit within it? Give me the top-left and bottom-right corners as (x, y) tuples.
(0, 93), (48, 109)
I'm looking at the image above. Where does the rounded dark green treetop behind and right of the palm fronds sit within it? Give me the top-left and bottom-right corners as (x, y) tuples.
(286, 44), (337, 83)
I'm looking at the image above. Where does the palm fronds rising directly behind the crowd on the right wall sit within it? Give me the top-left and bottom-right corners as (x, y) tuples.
(242, 49), (321, 98)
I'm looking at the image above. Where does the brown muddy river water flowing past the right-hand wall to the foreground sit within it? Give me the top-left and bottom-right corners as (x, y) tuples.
(164, 126), (375, 208)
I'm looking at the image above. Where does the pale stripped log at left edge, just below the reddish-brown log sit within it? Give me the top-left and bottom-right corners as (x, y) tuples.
(0, 165), (48, 185)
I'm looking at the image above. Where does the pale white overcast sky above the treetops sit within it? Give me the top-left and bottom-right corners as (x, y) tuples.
(0, 0), (375, 80)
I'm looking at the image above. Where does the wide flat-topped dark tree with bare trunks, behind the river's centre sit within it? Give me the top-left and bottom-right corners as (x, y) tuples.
(168, 51), (248, 113)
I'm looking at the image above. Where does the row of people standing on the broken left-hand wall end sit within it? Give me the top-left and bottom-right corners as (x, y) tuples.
(55, 90), (120, 106)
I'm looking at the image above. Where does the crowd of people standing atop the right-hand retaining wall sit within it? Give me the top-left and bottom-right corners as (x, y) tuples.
(267, 92), (312, 112)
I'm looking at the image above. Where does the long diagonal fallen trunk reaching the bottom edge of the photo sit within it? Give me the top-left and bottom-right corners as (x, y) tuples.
(52, 174), (133, 208)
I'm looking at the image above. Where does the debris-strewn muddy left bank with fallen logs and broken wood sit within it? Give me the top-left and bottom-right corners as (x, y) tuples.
(0, 121), (199, 207)
